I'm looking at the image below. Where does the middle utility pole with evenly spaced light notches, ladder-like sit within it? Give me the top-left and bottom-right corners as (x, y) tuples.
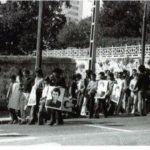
(89, 0), (100, 72)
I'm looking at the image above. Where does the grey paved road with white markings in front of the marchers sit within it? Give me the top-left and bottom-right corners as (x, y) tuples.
(0, 115), (150, 146)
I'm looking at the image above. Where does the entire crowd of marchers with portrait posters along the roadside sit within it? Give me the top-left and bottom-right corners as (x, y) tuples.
(7, 65), (150, 126)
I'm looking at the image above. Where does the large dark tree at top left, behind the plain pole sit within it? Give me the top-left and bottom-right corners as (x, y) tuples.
(0, 1), (68, 54)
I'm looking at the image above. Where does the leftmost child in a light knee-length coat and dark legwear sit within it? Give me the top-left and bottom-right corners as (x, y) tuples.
(6, 75), (21, 124)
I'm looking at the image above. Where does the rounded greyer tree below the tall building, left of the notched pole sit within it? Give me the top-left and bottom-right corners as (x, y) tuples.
(58, 20), (91, 48)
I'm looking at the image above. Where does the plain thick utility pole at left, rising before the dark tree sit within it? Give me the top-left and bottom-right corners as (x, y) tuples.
(35, 0), (43, 68)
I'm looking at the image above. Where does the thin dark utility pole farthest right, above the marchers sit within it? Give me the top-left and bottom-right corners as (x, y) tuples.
(142, 1), (147, 65)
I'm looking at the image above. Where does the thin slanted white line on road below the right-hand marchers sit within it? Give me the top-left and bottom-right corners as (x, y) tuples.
(85, 124), (133, 133)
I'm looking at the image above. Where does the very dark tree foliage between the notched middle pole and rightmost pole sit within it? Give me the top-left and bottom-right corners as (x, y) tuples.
(99, 1), (143, 38)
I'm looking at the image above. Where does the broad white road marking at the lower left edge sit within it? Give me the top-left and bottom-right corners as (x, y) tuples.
(0, 137), (38, 143)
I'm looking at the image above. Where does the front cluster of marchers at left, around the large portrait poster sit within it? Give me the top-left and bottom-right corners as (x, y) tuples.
(7, 68), (66, 125)
